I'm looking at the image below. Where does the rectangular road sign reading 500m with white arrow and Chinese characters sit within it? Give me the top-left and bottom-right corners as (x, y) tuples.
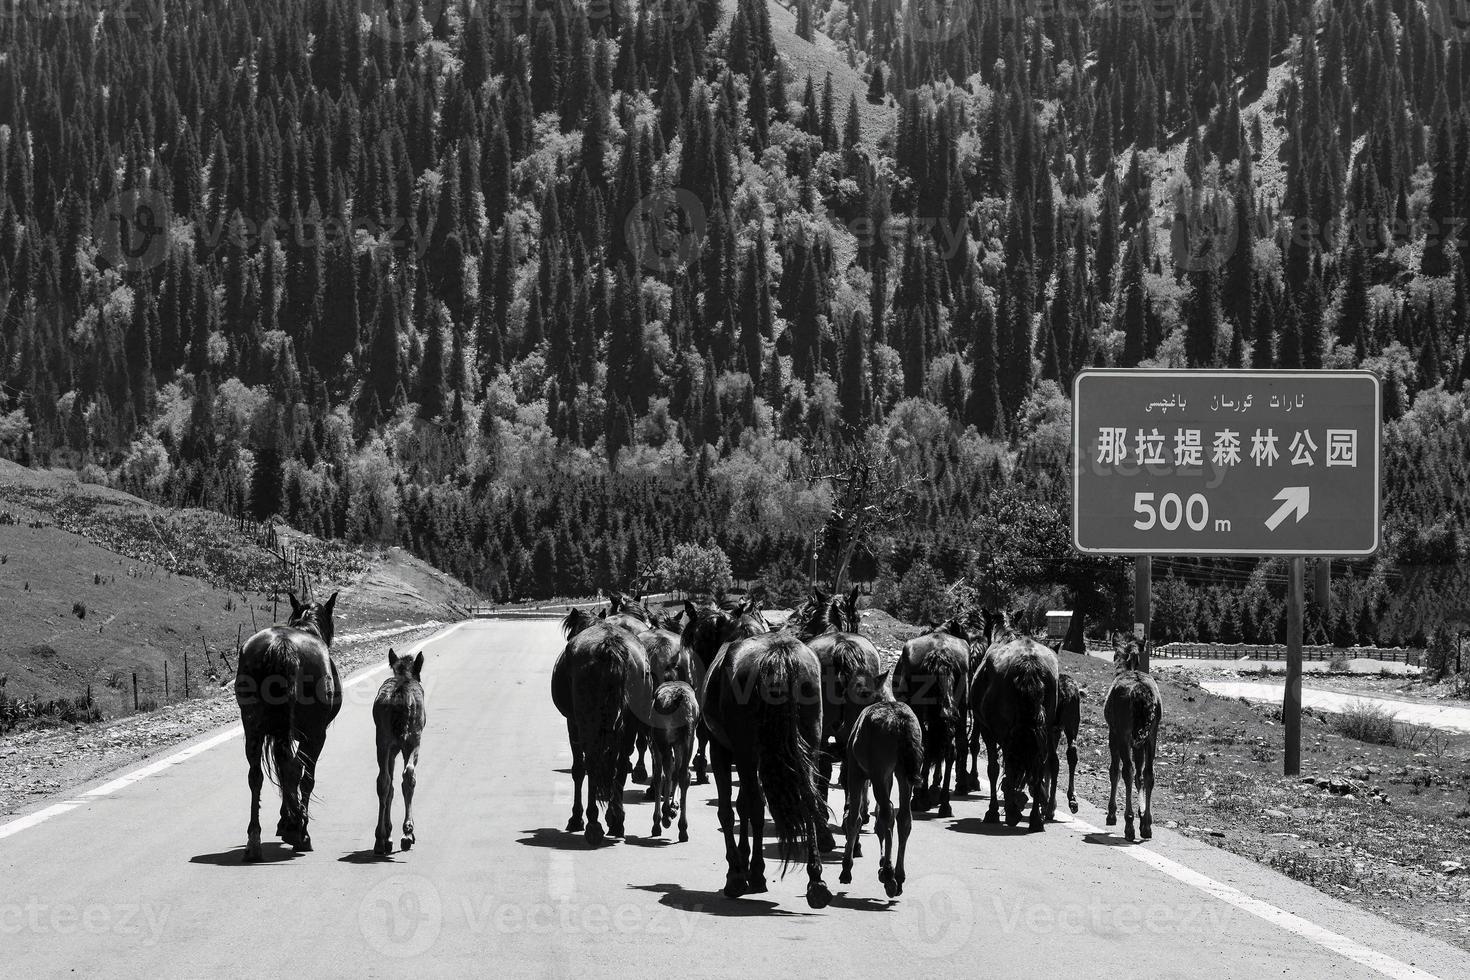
(1072, 370), (1382, 557)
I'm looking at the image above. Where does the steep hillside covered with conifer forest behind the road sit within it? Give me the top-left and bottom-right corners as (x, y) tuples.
(0, 0), (1470, 652)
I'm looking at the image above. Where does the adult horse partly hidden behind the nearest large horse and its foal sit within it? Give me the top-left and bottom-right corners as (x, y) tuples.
(795, 588), (883, 851)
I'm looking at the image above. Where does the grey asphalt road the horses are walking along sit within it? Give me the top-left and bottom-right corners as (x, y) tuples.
(0, 620), (1470, 980)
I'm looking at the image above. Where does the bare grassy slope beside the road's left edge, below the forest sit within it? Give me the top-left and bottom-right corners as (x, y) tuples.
(0, 461), (473, 716)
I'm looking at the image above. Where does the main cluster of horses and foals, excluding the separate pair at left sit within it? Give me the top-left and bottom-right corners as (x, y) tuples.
(551, 589), (1163, 908)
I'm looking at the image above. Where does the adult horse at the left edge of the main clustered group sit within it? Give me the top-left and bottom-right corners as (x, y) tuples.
(551, 608), (653, 843)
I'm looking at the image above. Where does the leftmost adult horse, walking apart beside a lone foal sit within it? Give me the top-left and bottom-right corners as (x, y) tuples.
(235, 592), (343, 864)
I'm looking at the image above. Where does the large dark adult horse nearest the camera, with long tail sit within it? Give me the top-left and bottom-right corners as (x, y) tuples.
(700, 630), (832, 908)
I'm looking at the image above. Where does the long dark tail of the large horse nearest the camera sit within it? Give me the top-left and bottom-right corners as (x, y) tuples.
(756, 636), (825, 876)
